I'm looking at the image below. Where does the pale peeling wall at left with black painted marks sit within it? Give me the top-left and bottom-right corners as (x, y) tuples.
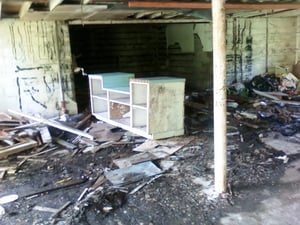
(0, 20), (77, 117)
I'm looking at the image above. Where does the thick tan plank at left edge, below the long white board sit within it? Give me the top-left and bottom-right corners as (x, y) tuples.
(0, 139), (37, 159)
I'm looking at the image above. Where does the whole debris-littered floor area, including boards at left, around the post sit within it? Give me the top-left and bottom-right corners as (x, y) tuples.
(0, 73), (300, 225)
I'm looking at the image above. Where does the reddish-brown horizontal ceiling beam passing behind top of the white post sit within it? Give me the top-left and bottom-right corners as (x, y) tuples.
(128, 1), (300, 10)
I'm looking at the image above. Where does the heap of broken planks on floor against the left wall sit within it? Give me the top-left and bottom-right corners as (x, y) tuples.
(0, 111), (93, 159)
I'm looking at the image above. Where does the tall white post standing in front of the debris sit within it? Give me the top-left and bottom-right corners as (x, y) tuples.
(212, 0), (227, 193)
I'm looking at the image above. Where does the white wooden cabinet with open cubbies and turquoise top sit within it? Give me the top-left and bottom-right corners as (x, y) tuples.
(89, 73), (185, 139)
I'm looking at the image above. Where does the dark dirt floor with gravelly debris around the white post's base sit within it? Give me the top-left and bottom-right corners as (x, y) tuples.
(0, 98), (298, 225)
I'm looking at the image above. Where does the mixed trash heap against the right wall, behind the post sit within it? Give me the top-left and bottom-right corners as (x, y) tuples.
(228, 72), (300, 136)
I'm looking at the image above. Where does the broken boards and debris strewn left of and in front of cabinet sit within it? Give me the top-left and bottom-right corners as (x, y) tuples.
(0, 110), (202, 224)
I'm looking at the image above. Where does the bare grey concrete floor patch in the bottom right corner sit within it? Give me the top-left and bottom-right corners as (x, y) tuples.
(220, 160), (300, 225)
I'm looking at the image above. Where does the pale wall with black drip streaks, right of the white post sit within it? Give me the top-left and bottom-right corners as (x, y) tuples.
(226, 17), (297, 85)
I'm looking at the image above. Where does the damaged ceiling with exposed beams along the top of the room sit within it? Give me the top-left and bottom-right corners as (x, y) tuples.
(0, 0), (300, 24)
